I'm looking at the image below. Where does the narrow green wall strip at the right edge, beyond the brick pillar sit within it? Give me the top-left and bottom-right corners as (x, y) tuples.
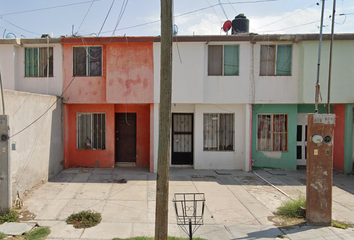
(344, 104), (353, 173)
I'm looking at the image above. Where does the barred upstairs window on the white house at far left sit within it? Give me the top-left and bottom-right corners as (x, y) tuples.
(25, 47), (53, 77)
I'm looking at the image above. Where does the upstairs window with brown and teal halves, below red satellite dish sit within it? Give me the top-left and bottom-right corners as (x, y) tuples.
(208, 45), (240, 76)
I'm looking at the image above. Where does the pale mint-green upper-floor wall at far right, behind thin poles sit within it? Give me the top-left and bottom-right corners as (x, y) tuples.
(299, 40), (354, 103)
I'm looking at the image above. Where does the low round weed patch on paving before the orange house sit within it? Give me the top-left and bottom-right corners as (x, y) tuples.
(66, 210), (102, 228)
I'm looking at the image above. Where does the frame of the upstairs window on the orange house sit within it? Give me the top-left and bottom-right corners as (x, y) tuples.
(72, 45), (103, 77)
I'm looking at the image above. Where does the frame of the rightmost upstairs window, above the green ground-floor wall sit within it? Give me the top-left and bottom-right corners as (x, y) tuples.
(259, 43), (293, 76)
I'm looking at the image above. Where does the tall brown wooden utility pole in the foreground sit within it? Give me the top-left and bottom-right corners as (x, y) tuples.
(155, 0), (172, 240)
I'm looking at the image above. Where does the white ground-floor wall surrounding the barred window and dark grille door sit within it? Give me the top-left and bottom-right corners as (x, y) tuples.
(154, 104), (250, 171)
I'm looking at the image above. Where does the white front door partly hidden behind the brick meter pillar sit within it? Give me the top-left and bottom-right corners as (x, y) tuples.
(296, 113), (307, 166)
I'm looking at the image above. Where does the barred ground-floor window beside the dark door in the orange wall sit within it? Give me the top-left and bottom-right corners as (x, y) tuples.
(77, 113), (106, 149)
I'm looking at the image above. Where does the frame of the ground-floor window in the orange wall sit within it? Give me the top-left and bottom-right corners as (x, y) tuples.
(76, 112), (107, 150)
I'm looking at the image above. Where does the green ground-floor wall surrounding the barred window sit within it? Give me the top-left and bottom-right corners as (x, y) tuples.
(252, 104), (297, 170)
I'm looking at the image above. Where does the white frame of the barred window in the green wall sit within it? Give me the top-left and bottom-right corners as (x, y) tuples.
(256, 113), (289, 152)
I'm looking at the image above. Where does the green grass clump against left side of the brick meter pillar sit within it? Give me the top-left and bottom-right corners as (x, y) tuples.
(276, 196), (306, 218)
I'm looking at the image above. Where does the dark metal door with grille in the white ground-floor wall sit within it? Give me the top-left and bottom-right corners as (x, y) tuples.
(171, 113), (193, 165)
